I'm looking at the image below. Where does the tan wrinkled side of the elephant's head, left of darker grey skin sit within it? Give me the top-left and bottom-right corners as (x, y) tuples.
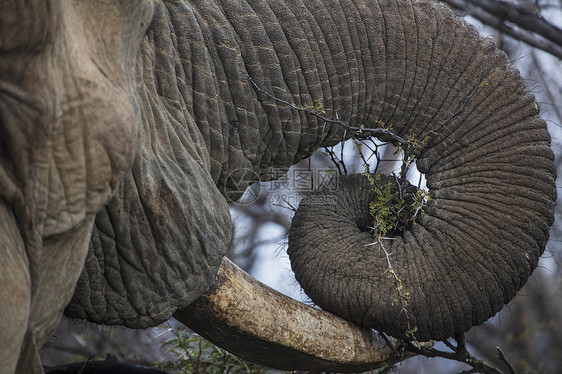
(0, 1), (152, 373)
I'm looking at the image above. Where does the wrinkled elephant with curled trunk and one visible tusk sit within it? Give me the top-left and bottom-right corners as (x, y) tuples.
(0, 0), (556, 373)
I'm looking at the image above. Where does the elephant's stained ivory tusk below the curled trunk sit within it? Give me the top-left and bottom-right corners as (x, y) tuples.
(174, 257), (414, 372)
